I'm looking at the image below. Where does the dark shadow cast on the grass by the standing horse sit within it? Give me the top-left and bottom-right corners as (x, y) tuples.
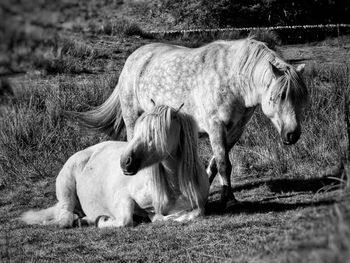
(205, 171), (348, 215)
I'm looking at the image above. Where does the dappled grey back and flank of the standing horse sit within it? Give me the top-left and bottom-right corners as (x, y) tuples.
(118, 39), (260, 132)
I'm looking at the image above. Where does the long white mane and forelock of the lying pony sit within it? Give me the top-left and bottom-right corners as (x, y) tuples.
(139, 105), (202, 214)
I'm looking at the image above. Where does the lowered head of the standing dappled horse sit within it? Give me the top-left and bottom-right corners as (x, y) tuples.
(261, 63), (308, 145)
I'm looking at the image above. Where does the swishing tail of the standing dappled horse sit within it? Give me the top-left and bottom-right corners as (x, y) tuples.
(65, 86), (125, 139)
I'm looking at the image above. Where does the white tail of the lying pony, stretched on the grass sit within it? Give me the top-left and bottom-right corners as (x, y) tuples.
(21, 206), (57, 225)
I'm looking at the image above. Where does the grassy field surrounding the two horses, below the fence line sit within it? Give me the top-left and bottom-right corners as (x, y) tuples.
(0, 1), (350, 262)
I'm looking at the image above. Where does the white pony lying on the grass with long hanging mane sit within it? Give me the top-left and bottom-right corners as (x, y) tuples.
(21, 106), (209, 228)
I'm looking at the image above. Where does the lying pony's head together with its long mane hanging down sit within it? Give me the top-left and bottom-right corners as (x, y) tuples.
(120, 105), (207, 213)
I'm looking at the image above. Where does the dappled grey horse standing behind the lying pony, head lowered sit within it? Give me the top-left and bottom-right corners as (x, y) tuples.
(71, 38), (308, 209)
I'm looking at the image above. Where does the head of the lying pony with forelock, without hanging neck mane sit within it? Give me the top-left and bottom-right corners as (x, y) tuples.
(120, 105), (181, 175)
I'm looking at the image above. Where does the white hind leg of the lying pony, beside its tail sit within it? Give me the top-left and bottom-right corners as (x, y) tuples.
(56, 165), (78, 228)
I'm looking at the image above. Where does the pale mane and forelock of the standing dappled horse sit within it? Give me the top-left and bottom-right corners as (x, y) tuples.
(235, 37), (308, 104)
